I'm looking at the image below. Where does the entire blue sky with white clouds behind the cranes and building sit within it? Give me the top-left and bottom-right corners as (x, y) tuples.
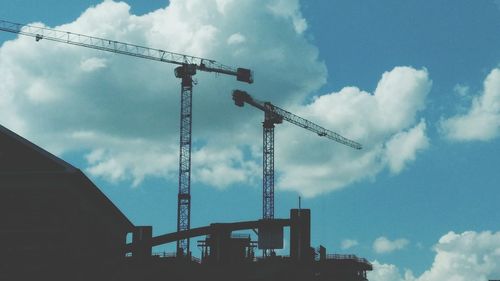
(0, 0), (500, 281)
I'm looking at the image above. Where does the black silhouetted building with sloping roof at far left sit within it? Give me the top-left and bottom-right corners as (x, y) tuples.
(0, 126), (134, 280)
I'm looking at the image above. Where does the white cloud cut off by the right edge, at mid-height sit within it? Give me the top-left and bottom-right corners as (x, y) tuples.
(440, 68), (500, 141)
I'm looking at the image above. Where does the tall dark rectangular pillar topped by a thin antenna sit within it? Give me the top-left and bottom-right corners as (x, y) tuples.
(290, 209), (312, 261)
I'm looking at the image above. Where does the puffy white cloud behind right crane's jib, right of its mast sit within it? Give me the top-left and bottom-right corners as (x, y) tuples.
(276, 67), (431, 196)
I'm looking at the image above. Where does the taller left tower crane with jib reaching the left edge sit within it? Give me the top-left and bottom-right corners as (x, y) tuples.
(0, 20), (253, 256)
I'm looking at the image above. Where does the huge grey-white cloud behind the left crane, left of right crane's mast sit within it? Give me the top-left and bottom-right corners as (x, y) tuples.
(0, 0), (326, 188)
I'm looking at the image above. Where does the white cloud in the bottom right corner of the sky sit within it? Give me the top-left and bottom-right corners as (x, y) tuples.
(368, 231), (500, 281)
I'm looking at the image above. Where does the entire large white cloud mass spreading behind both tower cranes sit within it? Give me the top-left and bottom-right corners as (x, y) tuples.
(0, 0), (431, 196)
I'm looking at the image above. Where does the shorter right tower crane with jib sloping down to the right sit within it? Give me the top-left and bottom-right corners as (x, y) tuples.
(233, 90), (362, 249)
